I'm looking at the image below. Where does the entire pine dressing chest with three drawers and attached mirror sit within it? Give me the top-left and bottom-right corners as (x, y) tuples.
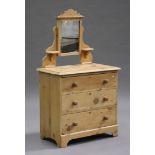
(37, 9), (120, 147)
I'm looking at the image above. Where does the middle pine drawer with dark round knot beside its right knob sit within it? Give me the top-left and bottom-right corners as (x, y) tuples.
(62, 89), (116, 114)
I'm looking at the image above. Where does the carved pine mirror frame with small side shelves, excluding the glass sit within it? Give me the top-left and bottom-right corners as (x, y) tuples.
(42, 9), (94, 68)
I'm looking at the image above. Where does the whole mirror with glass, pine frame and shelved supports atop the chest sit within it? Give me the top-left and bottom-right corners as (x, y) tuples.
(42, 9), (93, 68)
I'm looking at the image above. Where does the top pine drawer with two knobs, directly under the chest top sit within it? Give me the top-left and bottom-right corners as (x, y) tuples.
(61, 72), (117, 93)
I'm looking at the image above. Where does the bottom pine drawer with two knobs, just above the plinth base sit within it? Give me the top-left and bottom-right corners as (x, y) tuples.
(61, 106), (116, 134)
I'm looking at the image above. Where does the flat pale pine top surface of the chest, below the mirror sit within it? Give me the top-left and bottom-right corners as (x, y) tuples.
(37, 63), (120, 76)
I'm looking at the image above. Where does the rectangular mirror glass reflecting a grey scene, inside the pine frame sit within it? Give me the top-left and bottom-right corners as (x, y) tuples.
(61, 20), (80, 53)
